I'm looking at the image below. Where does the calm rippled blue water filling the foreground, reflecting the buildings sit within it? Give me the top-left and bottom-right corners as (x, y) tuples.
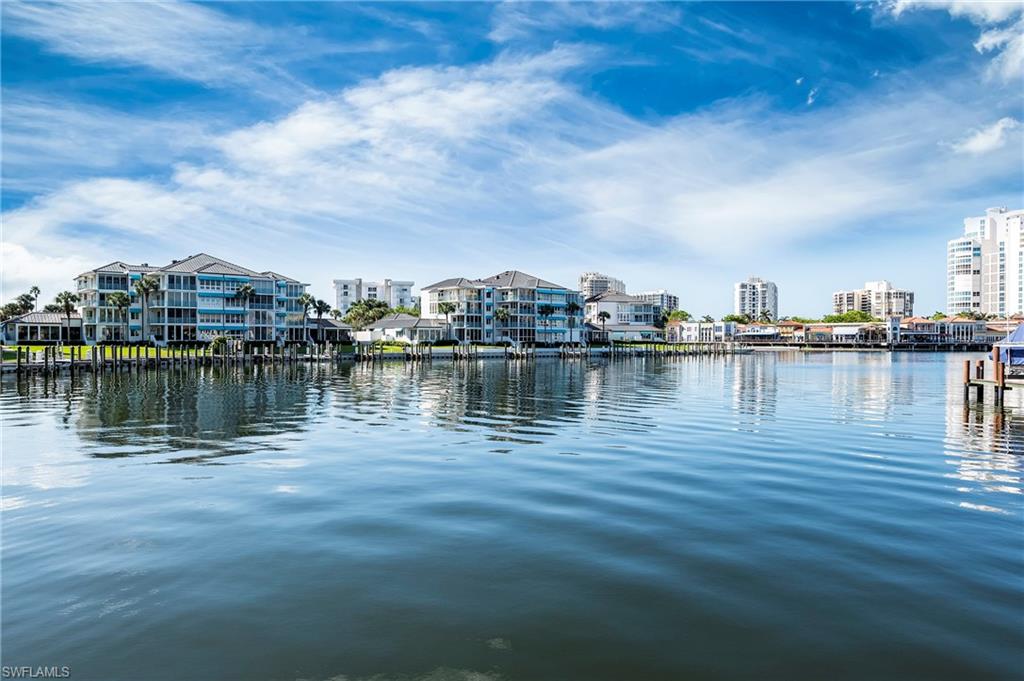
(0, 353), (1024, 681)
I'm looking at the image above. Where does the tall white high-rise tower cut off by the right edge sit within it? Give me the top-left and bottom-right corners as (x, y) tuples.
(946, 208), (1024, 316)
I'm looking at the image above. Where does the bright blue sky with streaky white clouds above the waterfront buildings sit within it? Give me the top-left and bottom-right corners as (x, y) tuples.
(0, 0), (1024, 316)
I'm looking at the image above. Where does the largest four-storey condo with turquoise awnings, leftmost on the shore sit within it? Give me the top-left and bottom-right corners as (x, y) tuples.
(76, 253), (308, 344)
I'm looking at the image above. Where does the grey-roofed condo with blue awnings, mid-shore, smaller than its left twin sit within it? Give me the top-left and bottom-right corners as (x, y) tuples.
(420, 270), (583, 343)
